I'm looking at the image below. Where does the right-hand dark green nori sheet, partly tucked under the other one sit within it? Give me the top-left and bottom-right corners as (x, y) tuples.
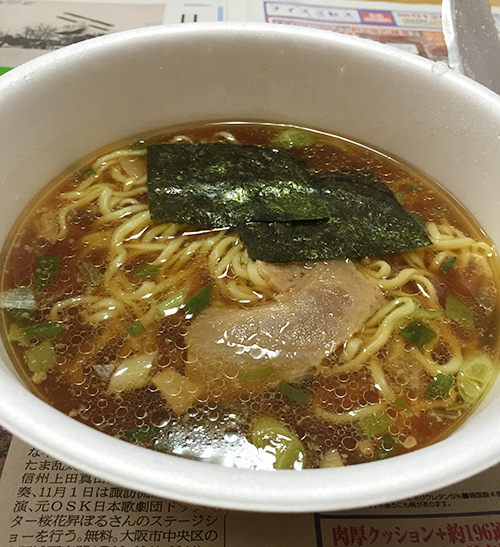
(238, 171), (431, 262)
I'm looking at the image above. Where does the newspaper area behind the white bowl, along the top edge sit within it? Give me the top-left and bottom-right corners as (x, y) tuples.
(0, 0), (484, 73)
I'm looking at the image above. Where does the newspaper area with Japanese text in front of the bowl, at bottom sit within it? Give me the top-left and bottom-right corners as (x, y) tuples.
(0, 437), (500, 547)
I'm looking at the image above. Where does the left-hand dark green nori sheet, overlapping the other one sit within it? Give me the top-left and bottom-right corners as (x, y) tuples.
(147, 143), (327, 228)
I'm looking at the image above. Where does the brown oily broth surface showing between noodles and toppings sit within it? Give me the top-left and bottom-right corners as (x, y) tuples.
(2, 123), (498, 468)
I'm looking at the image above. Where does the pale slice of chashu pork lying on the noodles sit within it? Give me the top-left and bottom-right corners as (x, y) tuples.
(186, 260), (383, 401)
